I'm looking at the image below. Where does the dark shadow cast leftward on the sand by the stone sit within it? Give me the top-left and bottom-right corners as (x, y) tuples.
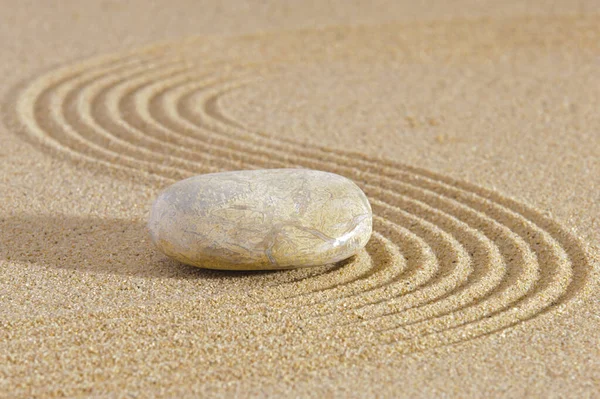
(0, 215), (314, 280)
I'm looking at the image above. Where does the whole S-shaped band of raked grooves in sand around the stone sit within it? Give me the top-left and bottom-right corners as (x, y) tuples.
(2, 13), (595, 396)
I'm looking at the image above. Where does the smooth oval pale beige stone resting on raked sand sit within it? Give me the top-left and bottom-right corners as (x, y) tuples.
(148, 169), (373, 270)
